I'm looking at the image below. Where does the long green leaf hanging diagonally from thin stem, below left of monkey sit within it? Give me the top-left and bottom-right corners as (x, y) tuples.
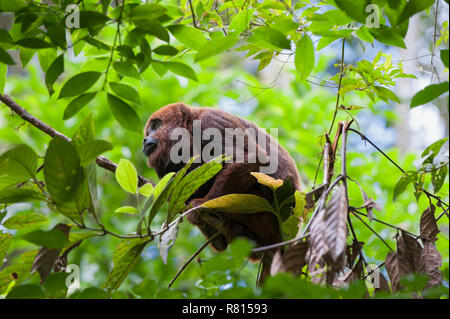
(104, 239), (147, 291)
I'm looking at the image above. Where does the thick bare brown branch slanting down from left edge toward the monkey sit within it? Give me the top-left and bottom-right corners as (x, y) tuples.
(0, 94), (154, 186)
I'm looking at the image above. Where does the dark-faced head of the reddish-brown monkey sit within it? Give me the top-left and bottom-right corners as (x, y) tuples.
(142, 103), (193, 178)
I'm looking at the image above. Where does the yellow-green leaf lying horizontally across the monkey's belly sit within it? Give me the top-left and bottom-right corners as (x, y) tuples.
(201, 194), (275, 214)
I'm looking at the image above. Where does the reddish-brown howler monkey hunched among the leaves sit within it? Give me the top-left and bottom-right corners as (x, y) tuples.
(143, 103), (300, 277)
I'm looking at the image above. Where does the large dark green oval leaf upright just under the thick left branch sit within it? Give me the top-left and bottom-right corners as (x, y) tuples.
(44, 136), (83, 205)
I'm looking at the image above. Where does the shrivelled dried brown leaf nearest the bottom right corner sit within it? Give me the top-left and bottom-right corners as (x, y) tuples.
(417, 241), (442, 288)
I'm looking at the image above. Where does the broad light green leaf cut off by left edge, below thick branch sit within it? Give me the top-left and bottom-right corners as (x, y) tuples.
(0, 144), (37, 189)
